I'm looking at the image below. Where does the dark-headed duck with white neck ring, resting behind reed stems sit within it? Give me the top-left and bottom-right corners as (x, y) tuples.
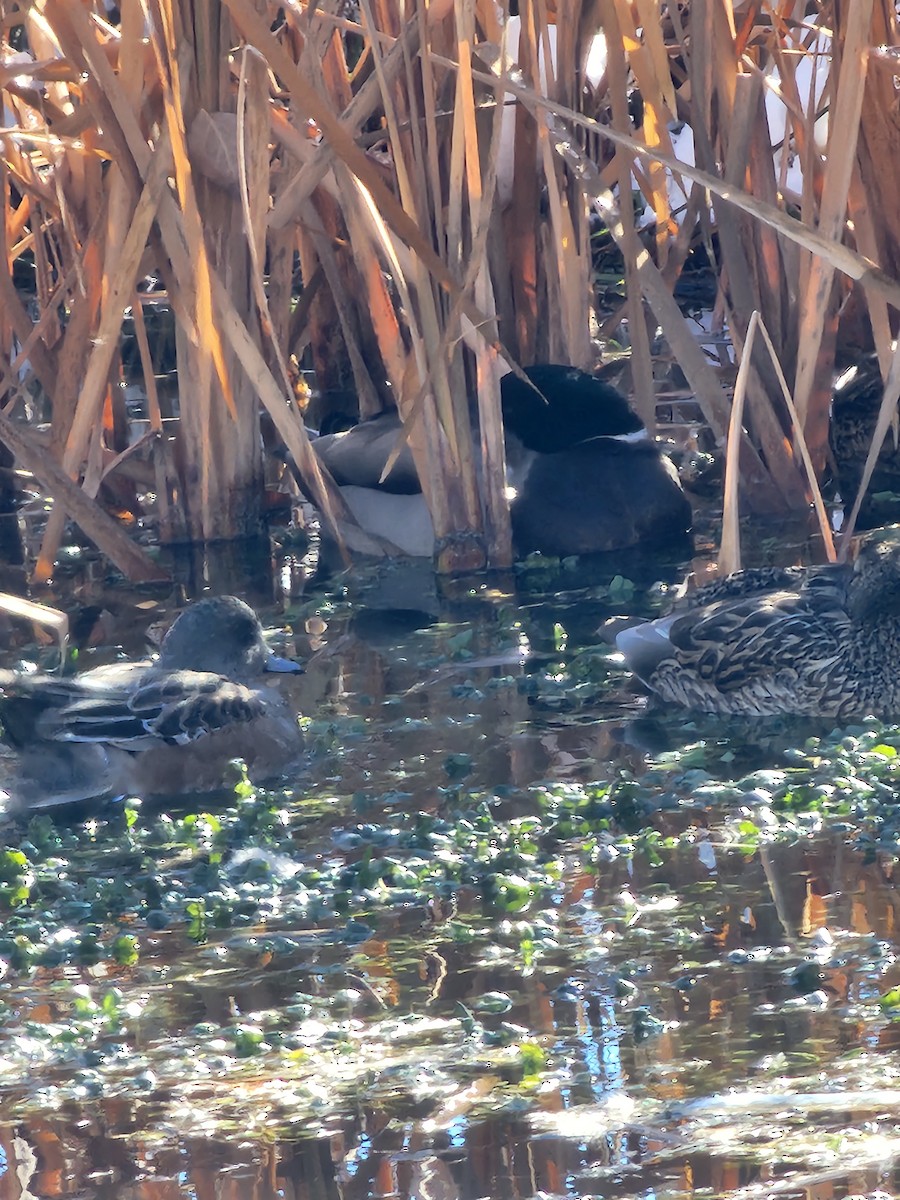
(313, 364), (691, 557)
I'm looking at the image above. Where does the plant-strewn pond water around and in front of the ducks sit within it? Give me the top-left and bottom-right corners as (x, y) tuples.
(0, 537), (900, 1200)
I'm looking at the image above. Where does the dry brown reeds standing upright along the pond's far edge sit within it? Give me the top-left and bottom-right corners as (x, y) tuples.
(0, 0), (900, 578)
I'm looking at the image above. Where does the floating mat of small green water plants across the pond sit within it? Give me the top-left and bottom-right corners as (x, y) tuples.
(7, 657), (900, 1190)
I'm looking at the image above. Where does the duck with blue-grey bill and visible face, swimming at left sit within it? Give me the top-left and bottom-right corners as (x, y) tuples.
(0, 595), (304, 809)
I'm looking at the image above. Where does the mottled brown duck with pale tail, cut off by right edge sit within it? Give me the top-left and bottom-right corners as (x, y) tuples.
(616, 530), (900, 722)
